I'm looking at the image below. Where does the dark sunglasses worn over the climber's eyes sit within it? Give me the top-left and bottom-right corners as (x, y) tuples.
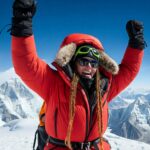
(77, 57), (99, 68)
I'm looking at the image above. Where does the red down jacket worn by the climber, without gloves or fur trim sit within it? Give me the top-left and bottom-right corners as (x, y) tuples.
(12, 34), (143, 150)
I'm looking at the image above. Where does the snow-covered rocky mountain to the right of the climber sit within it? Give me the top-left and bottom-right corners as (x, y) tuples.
(109, 91), (150, 144)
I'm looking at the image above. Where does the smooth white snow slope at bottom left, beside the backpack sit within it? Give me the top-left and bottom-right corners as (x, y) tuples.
(0, 118), (38, 150)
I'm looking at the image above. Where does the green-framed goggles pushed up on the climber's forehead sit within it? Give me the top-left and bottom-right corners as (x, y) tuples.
(75, 45), (100, 60)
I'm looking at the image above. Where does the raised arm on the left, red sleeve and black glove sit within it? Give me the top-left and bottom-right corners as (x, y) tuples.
(11, 0), (55, 99)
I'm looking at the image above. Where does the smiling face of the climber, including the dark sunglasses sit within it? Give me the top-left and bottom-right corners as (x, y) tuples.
(75, 57), (98, 79)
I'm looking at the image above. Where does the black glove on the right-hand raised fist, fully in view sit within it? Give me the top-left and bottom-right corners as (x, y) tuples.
(126, 20), (146, 49)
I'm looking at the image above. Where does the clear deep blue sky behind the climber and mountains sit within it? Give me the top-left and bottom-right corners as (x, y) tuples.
(0, 0), (150, 89)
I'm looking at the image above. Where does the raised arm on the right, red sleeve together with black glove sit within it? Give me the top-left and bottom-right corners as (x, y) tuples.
(108, 20), (145, 101)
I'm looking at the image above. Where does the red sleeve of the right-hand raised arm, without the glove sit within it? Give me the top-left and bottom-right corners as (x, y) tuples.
(108, 47), (144, 102)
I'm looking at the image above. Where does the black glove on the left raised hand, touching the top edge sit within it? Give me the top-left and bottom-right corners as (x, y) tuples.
(11, 0), (36, 37)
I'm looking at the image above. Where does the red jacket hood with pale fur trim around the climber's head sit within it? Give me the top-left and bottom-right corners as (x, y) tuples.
(54, 33), (119, 74)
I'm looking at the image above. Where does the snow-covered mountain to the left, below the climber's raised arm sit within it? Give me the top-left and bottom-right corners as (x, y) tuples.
(0, 69), (42, 125)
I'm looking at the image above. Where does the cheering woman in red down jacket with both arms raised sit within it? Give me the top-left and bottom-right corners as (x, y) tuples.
(11, 0), (145, 150)
